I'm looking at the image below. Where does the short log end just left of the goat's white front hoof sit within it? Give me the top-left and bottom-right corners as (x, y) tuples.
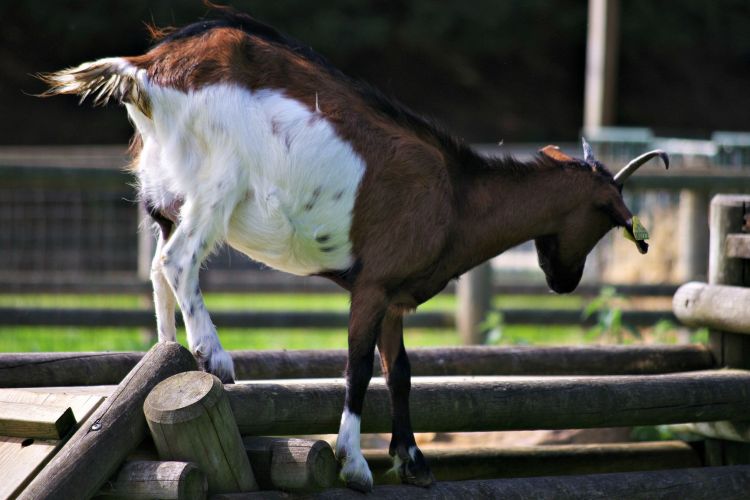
(242, 436), (338, 492)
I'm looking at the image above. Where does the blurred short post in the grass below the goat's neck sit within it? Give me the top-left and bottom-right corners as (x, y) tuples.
(456, 262), (492, 345)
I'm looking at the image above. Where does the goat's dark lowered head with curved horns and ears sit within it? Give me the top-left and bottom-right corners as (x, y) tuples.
(535, 139), (669, 293)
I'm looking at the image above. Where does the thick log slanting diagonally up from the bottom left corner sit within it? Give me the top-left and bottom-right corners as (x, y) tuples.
(19, 342), (196, 499)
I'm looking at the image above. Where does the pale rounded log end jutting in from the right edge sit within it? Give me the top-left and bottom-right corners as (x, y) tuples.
(672, 282), (750, 334)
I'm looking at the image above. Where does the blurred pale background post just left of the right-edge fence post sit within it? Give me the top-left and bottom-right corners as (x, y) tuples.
(677, 189), (709, 282)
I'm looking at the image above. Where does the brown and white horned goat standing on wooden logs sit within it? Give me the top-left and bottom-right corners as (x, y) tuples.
(42, 7), (668, 491)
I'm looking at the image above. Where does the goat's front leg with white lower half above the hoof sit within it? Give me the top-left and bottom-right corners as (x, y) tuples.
(336, 287), (386, 492)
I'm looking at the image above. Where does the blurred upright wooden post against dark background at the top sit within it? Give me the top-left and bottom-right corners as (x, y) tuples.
(583, 0), (620, 134)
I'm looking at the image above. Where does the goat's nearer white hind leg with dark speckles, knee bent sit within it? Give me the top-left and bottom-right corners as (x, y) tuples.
(158, 201), (234, 383)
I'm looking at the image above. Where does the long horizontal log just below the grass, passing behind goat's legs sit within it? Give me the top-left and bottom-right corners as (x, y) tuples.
(0, 345), (714, 387)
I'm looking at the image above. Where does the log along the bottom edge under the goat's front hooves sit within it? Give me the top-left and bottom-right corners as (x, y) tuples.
(212, 465), (750, 500)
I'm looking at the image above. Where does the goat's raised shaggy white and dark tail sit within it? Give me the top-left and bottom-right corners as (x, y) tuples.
(37, 57), (151, 117)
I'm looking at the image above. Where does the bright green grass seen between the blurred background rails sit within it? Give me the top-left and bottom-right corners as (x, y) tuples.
(0, 293), (585, 352)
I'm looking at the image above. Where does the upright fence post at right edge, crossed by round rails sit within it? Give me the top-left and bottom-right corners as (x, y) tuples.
(706, 195), (750, 465)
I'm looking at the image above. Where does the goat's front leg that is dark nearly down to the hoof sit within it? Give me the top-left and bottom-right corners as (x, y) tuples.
(378, 311), (435, 486)
